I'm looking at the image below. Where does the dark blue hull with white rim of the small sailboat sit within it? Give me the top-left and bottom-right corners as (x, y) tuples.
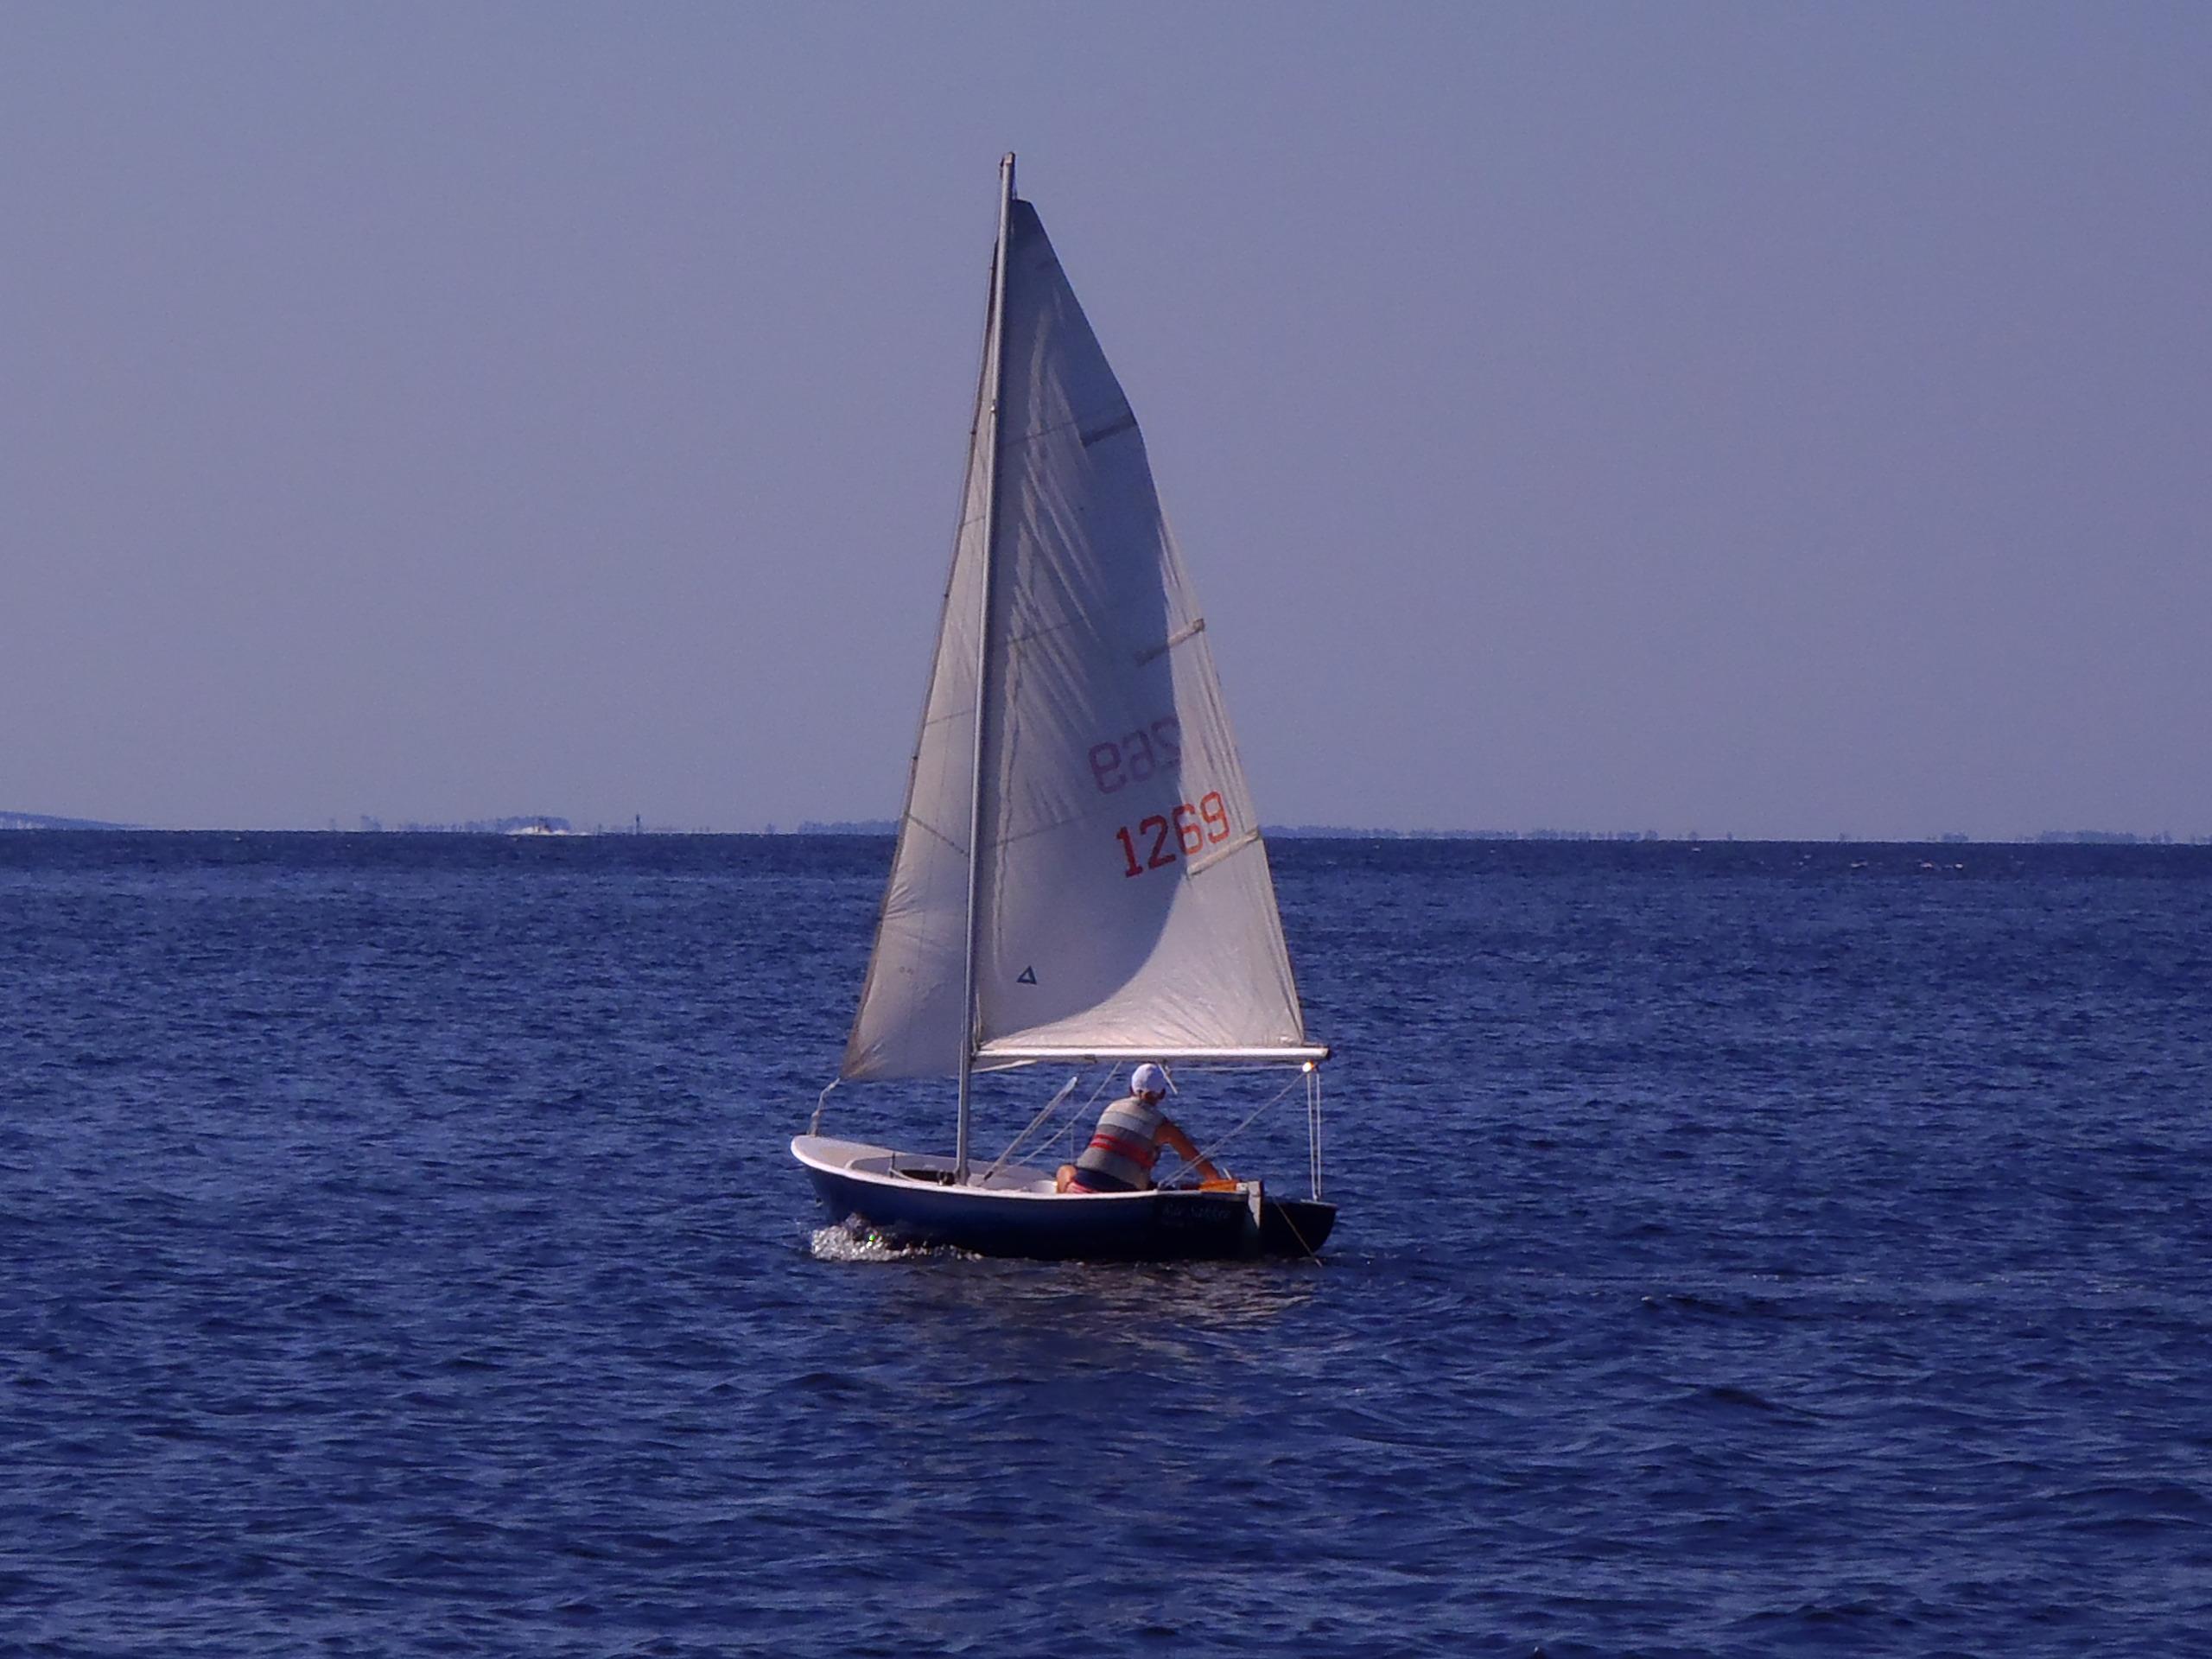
(791, 1137), (1336, 1261)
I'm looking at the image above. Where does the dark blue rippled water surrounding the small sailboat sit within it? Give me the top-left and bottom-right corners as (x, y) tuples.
(0, 834), (2212, 1659)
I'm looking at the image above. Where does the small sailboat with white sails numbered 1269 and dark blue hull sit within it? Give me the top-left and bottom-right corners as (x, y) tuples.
(791, 155), (1336, 1261)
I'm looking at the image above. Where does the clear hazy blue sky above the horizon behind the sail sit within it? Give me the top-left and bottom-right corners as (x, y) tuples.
(0, 3), (2212, 836)
